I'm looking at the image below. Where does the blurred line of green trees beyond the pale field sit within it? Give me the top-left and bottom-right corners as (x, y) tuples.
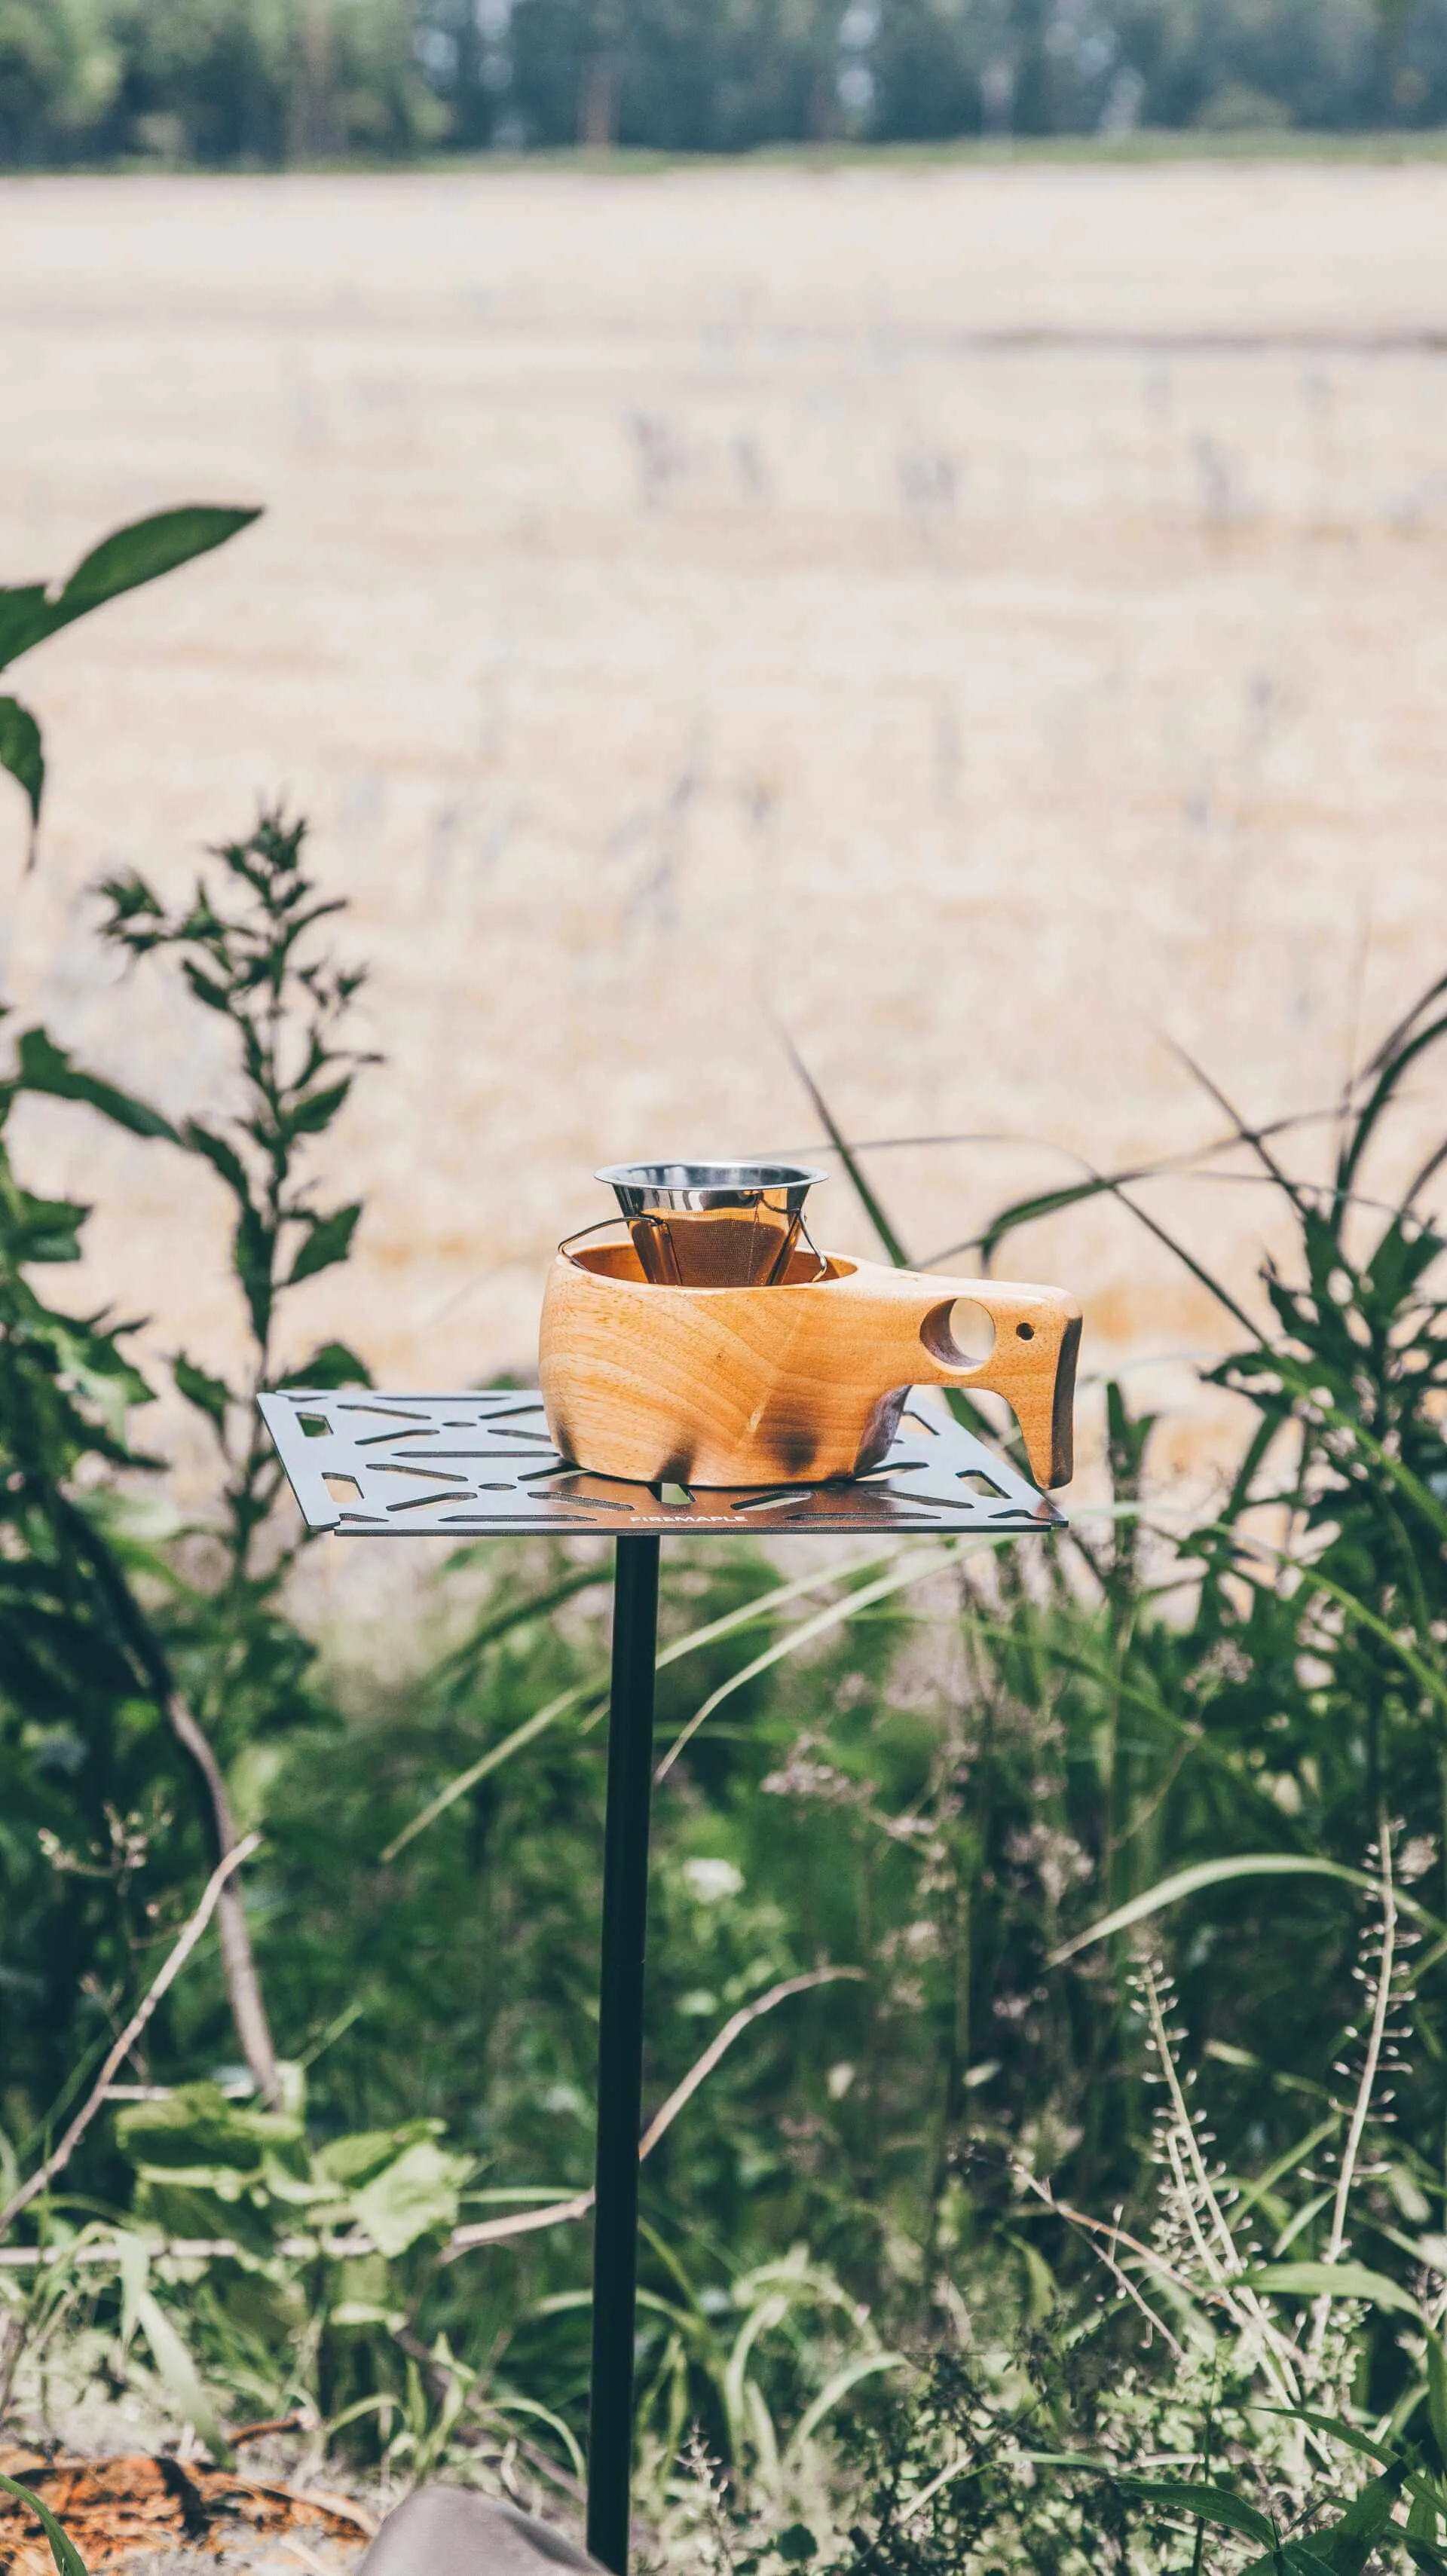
(0, 0), (1447, 167)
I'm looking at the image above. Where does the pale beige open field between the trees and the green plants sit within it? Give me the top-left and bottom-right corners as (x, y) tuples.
(0, 165), (1447, 1587)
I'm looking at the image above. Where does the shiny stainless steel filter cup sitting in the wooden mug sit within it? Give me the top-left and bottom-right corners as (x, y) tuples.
(595, 1162), (827, 1288)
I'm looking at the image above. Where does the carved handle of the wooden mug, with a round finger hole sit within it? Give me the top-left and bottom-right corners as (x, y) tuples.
(870, 1270), (1081, 1487)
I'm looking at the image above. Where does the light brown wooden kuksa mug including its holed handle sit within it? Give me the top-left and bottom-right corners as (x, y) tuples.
(538, 1236), (1081, 1487)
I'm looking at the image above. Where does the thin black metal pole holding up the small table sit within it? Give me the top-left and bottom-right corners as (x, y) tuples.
(587, 1532), (659, 2576)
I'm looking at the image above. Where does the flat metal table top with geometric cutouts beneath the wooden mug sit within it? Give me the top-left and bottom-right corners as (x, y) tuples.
(260, 1386), (1063, 1538)
